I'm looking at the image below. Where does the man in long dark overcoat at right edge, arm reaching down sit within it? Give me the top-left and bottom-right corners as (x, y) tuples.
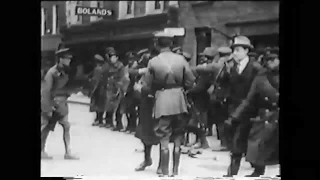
(230, 47), (280, 177)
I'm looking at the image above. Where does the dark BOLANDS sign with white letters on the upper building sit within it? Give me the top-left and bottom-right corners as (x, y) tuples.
(76, 6), (113, 16)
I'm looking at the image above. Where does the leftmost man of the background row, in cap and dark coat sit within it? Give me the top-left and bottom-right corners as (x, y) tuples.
(90, 54), (105, 126)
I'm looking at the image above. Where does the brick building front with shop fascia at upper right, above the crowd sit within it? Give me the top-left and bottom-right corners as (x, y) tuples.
(179, 1), (279, 64)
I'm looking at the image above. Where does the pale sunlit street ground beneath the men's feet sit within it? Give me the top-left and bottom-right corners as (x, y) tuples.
(41, 103), (279, 180)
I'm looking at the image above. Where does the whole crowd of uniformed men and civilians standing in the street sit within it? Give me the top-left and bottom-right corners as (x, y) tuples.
(41, 29), (280, 177)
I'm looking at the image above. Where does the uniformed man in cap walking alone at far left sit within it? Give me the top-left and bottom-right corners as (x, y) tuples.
(41, 48), (79, 159)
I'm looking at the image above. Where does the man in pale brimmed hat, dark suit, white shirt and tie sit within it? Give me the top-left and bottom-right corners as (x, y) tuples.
(225, 36), (262, 177)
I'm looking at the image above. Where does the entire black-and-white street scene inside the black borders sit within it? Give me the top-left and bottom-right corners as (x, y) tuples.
(39, 1), (281, 180)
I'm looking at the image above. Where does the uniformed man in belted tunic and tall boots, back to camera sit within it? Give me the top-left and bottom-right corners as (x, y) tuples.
(135, 32), (195, 176)
